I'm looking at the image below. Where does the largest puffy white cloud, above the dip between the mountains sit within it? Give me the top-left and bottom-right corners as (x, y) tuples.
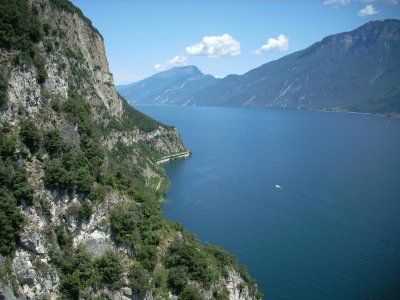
(185, 33), (240, 57)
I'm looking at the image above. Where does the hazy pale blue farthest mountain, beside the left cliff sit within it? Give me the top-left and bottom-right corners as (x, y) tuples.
(116, 66), (218, 104)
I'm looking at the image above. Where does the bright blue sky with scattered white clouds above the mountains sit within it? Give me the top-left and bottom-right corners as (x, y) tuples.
(72, 0), (400, 84)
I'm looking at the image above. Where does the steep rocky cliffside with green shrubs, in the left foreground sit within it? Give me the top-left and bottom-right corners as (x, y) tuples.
(0, 0), (261, 300)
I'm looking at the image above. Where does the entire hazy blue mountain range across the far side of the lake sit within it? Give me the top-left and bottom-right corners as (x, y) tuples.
(117, 19), (400, 114)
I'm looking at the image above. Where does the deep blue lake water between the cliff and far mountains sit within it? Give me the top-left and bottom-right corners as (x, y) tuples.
(138, 106), (400, 299)
